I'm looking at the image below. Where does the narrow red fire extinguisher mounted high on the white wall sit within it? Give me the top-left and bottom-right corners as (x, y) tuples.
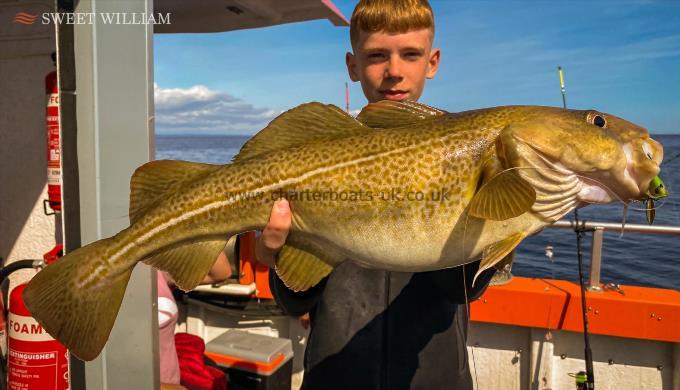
(45, 53), (61, 214)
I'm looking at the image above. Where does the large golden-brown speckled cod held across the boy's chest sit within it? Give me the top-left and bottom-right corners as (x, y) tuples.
(24, 102), (663, 360)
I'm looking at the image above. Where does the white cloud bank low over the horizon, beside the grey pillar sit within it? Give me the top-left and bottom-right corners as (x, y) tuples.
(154, 83), (279, 134)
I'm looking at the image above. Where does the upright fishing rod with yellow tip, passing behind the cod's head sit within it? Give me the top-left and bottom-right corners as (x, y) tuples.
(557, 66), (595, 390)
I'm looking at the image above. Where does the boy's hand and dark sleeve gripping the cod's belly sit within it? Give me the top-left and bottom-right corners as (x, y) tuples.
(255, 199), (326, 316)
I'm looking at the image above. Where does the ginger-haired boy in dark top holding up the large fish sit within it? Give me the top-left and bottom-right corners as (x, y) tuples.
(255, 0), (493, 389)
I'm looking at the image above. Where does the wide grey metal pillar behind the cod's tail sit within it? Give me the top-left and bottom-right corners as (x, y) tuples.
(71, 0), (160, 390)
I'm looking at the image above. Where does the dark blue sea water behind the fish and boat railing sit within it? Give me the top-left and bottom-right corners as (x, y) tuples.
(156, 135), (680, 290)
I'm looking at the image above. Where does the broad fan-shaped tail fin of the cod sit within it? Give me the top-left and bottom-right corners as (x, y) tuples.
(23, 238), (133, 361)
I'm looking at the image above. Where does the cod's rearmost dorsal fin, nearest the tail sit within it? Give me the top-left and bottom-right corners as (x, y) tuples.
(129, 160), (220, 224)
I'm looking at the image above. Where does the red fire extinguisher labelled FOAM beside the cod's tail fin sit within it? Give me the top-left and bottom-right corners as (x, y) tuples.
(7, 244), (69, 390)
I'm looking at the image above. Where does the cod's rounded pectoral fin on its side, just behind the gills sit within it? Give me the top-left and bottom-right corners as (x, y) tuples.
(470, 170), (536, 221)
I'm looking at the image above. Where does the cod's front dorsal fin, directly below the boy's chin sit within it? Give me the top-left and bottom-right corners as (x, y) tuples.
(357, 100), (446, 129)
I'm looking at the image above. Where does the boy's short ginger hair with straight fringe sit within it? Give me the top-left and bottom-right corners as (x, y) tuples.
(349, 0), (434, 47)
